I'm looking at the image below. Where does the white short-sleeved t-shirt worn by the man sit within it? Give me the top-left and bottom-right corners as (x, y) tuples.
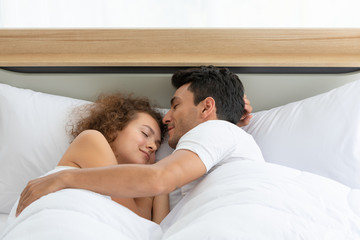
(175, 120), (264, 198)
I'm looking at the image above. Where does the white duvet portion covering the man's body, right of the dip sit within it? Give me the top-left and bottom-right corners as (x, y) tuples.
(161, 161), (360, 240)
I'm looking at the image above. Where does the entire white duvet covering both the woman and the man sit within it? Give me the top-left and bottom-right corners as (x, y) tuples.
(3, 161), (360, 240)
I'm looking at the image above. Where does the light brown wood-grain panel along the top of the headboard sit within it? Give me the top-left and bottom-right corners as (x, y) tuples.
(0, 29), (360, 67)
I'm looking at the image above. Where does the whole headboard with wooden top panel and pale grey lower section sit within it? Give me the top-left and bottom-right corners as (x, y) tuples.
(0, 29), (360, 111)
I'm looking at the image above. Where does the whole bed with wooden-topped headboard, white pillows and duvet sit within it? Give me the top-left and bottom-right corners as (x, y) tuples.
(0, 29), (360, 239)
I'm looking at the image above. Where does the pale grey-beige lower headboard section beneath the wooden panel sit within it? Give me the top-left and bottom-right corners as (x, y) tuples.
(0, 69), (360, 111)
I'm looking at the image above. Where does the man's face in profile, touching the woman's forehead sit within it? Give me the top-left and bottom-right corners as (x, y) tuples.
(163, 83), (202, 148)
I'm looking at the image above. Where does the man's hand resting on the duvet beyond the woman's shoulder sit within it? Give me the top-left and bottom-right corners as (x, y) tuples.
(16, 171), (65, 216)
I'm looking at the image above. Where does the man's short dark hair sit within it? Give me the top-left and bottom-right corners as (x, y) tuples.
(171, 66), (245, 123)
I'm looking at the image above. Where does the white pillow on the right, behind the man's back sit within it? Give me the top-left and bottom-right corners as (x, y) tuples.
(244, 80), (360, 188)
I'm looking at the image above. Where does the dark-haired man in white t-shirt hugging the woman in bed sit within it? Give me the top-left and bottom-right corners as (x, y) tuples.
(17, 66), (262, 215)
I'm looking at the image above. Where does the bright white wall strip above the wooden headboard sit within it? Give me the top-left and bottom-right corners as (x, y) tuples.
(0, 0), (360, 28)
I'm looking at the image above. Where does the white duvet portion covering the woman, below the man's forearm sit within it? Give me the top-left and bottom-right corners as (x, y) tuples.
(0, 189), (162, 240)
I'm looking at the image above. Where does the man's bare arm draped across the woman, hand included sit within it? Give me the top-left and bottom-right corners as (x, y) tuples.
(17, 150), (206, 215)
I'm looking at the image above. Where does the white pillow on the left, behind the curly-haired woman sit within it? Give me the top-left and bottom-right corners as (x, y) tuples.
(0, 84), (86, 213)
